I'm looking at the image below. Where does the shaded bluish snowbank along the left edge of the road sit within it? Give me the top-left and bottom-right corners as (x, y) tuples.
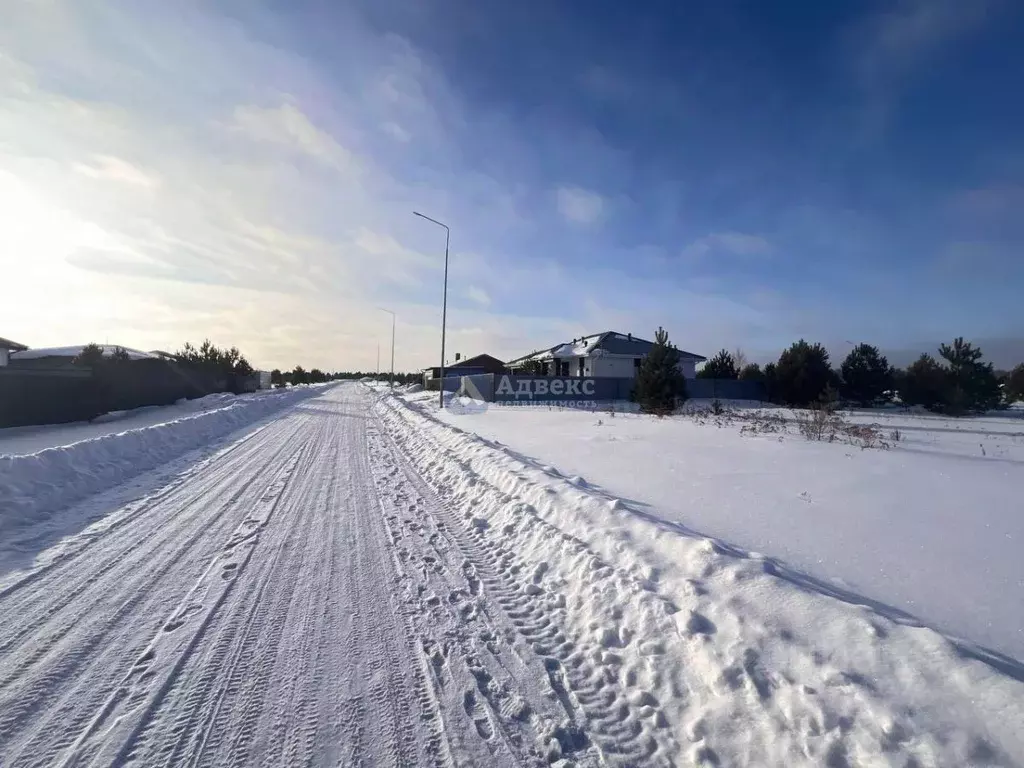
(0, 387), (323, 535)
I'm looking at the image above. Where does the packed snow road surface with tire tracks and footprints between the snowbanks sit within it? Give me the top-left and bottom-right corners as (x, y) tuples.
(0, 387), (656, 766)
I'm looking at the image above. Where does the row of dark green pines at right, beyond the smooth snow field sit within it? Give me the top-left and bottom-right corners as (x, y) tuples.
(697, 337), (1024, 416)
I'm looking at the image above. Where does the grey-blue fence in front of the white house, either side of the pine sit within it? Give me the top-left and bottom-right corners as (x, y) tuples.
(460, 374), (764, 402)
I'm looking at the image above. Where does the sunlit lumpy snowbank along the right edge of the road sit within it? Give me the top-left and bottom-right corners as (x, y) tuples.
(377, 397), (1024, 766)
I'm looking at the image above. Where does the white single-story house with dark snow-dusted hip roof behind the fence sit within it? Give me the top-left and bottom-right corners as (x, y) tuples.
(508, 331), (708, 379)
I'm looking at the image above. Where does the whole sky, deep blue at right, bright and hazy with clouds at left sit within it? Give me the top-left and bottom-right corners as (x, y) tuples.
(0, 0), (1024, 369)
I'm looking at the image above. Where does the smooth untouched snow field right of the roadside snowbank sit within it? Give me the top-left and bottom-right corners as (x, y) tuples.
(423, 393), (1024, 660)
